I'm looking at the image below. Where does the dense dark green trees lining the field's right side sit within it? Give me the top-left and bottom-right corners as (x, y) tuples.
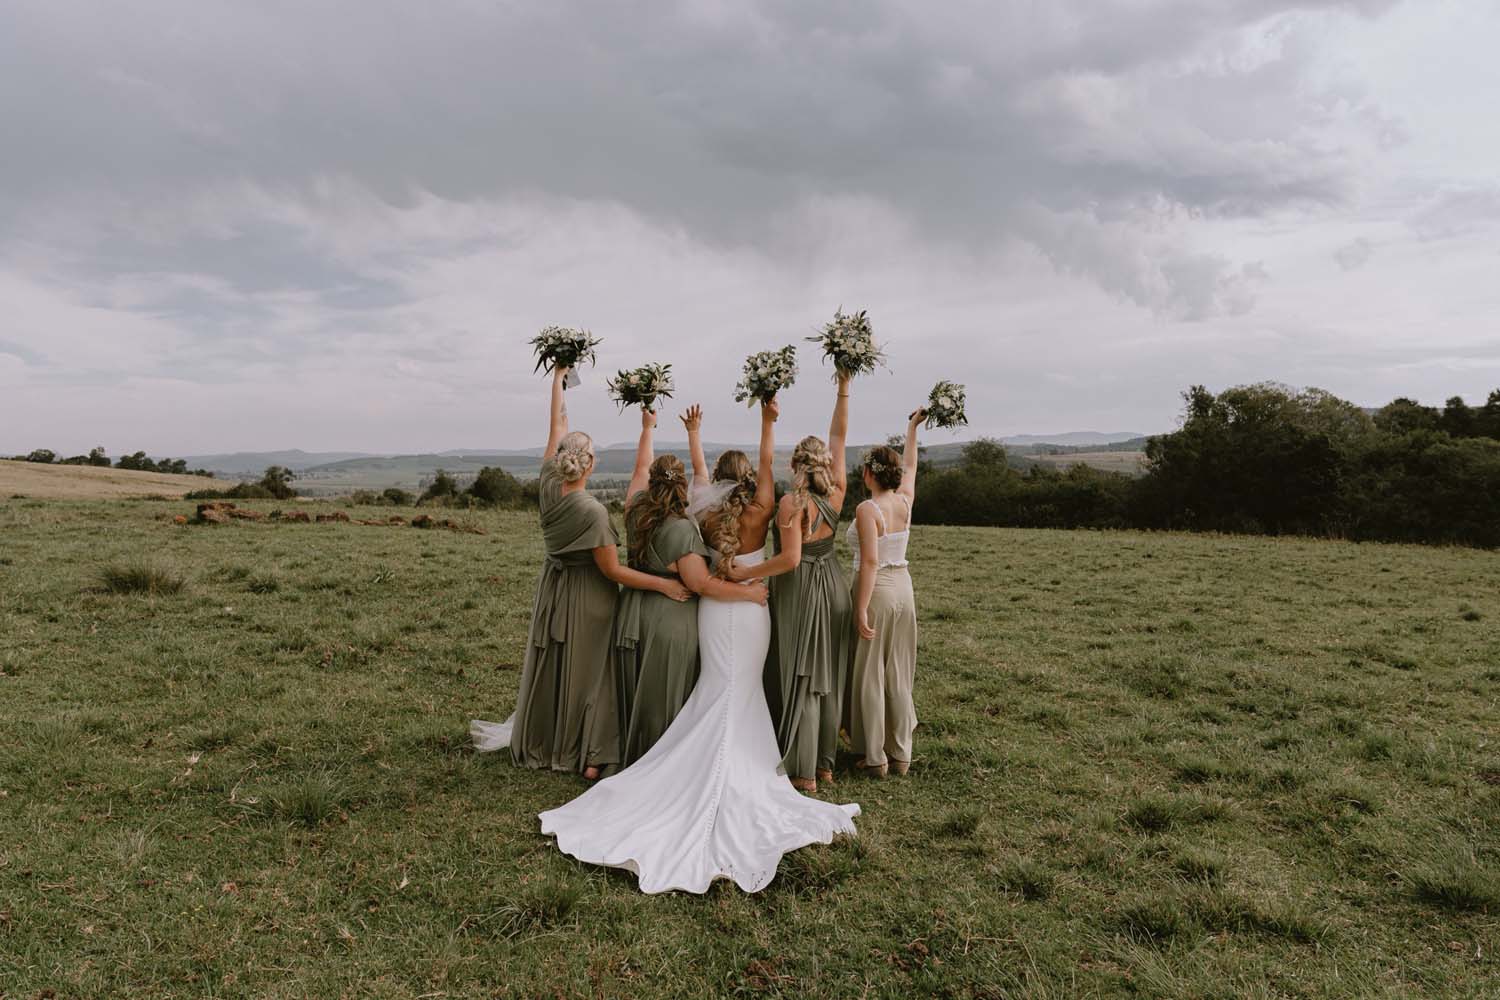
(870, 382), (1500, 547)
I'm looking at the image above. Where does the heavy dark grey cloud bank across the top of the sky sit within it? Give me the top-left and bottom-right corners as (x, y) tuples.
(0, 0), (1392, 318)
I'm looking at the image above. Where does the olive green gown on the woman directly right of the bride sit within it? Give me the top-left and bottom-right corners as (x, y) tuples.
(767, 493), (854, 778)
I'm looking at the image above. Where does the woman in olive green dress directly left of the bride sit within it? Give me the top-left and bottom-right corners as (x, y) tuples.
(615, 411), (767, 766)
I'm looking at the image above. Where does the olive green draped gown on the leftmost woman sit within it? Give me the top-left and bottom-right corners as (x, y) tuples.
(510, 459), (621, 774)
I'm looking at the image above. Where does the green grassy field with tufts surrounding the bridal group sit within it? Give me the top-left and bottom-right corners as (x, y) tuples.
(0, 501), (1500, 1000)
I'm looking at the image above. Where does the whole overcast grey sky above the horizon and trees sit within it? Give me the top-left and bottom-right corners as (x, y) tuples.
(0, 0), (1500, 454)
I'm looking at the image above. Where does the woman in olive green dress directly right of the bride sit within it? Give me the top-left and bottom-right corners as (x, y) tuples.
(732, 375), (854, 792)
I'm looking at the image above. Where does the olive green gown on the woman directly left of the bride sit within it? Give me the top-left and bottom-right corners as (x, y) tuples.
(615, 508), (708, 766)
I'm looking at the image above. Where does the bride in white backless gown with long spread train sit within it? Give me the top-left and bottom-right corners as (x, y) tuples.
(542, 400), (860, 892)
